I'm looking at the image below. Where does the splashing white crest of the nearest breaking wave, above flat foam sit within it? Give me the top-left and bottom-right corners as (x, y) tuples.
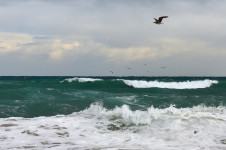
(78, 102), (226, 127)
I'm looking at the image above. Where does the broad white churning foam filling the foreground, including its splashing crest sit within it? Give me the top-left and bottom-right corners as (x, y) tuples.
(0, 104), (226, 150)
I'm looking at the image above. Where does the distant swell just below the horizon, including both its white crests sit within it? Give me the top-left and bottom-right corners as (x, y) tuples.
(61, 77), (218, 89)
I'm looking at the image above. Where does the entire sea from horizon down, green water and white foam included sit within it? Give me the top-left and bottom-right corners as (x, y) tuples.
(0, 77), (226, 150)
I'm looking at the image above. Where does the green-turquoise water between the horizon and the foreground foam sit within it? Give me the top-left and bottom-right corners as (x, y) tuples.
(0, 77), (226, 118)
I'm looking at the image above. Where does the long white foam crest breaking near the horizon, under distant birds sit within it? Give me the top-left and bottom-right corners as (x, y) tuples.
(122, 79), (218, 89)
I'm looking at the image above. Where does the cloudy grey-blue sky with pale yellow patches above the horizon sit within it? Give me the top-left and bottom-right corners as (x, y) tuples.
(0, 0), (226, 76)
